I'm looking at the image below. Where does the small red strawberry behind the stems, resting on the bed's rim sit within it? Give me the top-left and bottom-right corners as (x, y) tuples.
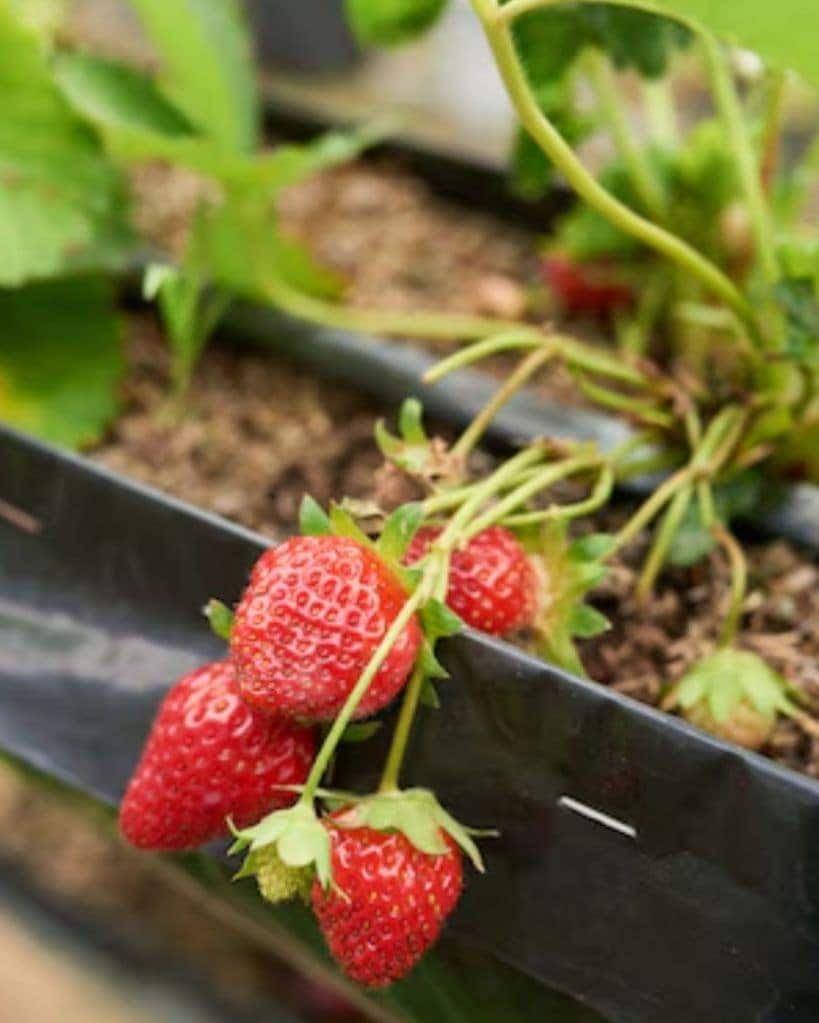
(406, 526), (540, 635)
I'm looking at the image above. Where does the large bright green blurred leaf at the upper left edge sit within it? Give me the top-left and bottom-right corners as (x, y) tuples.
(0, 4), (132, 286)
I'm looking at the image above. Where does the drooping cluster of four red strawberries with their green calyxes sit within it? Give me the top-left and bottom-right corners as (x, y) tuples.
(121, 504), (539, 987)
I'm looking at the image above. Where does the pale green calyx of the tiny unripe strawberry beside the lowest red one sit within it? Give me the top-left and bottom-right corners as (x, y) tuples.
(229, 801), (331, 887)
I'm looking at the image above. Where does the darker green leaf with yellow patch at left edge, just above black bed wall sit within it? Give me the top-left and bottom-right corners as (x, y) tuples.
(0, 278), (123, 447)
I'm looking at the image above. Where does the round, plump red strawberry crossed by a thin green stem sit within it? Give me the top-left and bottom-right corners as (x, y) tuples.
(230, 536), (421, 720)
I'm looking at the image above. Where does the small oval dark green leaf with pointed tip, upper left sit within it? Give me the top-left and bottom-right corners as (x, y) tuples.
(53, 53), (194, 135)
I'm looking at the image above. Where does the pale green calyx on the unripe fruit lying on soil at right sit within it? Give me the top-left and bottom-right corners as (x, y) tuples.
(664, 650), (801, 725)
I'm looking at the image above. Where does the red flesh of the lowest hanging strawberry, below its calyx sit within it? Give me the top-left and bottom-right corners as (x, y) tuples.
(313, 811), (463, 987)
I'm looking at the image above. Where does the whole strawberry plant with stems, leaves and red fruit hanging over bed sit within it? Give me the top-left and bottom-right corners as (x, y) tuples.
(27, 0), (819, 987)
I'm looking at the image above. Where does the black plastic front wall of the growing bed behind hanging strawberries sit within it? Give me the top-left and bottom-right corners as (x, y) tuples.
(0, 411), (819, 1023)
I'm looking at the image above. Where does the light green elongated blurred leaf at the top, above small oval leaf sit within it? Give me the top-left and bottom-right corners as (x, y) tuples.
(127, 0), (259, 151)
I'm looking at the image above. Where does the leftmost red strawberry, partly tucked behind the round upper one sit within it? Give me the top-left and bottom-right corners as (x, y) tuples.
(120, 661), (315, 850)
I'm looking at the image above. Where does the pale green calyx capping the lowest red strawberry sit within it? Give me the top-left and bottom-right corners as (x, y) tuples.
(322, 789), (498, 874)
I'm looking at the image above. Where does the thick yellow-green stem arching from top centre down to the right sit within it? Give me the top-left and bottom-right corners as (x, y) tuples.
(470, 0), (757, 332)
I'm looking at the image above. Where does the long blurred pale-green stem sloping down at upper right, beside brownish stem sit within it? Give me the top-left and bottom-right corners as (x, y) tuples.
(699, 31), (779, 282)
